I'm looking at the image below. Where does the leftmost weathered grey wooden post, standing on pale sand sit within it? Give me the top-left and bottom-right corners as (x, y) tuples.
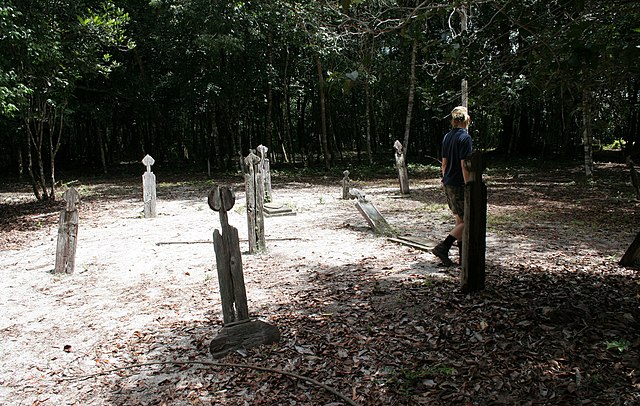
(54, 187), (80, 274)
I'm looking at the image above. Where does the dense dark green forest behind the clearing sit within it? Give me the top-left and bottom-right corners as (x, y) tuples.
(0, 0), (640, 199)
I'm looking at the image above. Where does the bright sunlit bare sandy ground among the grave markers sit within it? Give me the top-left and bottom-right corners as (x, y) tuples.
(0, 183), (450, 405)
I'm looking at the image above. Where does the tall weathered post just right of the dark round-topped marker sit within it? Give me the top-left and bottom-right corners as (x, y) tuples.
(244, 152), (266, 254)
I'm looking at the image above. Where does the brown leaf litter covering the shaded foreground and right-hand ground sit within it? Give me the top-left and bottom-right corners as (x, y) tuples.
(3, 160), (640, 405)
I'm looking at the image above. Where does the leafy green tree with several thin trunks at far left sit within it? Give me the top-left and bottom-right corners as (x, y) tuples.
(0, 0), (127, 200)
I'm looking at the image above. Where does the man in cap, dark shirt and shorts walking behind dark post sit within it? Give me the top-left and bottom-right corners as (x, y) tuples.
(431, 106), (472, 266)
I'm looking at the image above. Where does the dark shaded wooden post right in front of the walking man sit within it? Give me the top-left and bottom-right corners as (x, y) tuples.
(462, 151), (487, 293)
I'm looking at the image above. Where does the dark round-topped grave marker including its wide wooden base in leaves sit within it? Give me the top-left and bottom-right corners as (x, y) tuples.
(208, 186), (280, 358)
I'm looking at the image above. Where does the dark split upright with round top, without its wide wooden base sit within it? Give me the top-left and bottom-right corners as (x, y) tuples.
(208, 186), (249, 324)
